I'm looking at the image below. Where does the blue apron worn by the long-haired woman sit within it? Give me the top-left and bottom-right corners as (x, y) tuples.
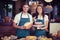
(35, 18), (46, 37)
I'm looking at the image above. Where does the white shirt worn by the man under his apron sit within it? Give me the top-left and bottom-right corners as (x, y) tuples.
(14, 12), (33, 25)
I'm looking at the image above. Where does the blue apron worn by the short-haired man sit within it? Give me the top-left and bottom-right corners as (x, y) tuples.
(16, 14), (30, 38)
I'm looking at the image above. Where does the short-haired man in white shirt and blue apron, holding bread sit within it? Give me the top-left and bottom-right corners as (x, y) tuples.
(13, 4), (32, 38)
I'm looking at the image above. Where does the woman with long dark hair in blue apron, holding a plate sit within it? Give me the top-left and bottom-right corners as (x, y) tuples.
(34, 5), (48, 37)
